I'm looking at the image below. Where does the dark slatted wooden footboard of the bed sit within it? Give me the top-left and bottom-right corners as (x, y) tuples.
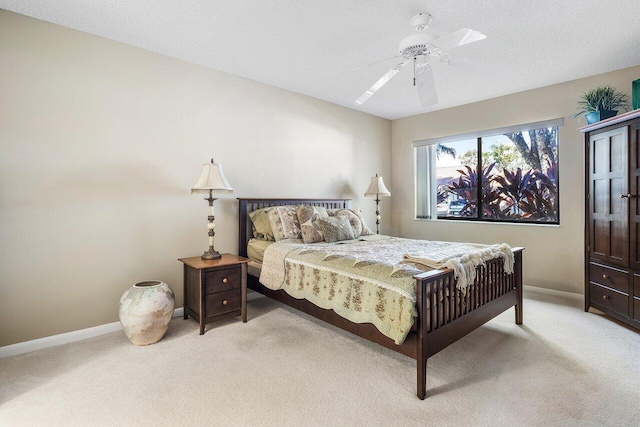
(415, 248), (523, 399)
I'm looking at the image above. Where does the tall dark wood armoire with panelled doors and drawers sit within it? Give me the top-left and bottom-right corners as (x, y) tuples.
(580, 110), (640, 328)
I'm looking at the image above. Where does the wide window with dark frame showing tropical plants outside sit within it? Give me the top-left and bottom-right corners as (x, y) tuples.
(414, 119), (564, 224)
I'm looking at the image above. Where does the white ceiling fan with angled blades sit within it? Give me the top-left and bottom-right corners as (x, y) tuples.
(356, 13), (487, 107)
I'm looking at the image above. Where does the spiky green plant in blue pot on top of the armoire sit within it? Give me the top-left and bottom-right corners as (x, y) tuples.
(573, 85), (629, 124)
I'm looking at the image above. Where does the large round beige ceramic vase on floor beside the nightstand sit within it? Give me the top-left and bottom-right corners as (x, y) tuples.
(119, 280), (176, 345)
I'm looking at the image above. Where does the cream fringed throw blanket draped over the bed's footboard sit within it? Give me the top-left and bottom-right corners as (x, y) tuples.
(403, 242), (515, 289)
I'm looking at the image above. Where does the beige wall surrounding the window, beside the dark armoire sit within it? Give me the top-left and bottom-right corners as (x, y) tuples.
(390, 67), (640, 293)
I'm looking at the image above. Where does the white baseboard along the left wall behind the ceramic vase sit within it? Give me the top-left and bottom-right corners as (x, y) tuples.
(0, 307), (184, 359)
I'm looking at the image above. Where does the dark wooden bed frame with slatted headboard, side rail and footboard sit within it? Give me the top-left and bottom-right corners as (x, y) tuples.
(238, 198), (524, 399)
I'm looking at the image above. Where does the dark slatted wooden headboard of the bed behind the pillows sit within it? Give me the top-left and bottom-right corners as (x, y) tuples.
(238, 198), (351, 257)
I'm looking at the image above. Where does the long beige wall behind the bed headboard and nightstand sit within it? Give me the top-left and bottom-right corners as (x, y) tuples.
(0, 11), (391, 346)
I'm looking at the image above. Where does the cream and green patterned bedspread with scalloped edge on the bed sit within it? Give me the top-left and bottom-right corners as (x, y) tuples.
(260, 235), (513, 344)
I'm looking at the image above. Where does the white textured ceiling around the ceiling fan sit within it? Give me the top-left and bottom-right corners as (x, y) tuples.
(0, 0), (640, 119)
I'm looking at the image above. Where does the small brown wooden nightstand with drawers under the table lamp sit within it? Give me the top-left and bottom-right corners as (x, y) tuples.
(179, 254), (249, 335)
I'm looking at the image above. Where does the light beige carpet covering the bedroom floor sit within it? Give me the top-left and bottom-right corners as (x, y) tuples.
(0, 294), (640, 426)
